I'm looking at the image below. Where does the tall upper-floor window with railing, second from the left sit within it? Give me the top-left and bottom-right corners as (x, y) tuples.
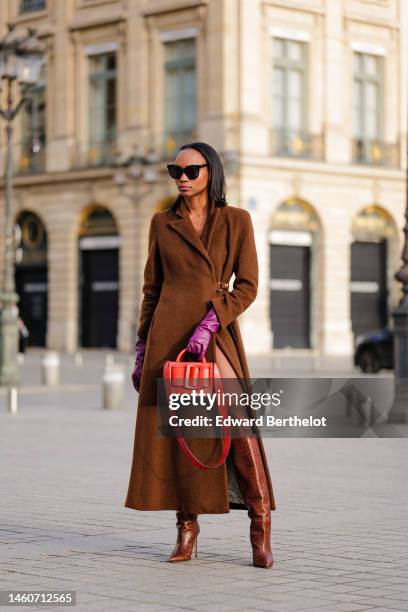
(86, 52), (117, 165)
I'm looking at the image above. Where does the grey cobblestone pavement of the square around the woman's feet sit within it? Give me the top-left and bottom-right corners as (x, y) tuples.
(0, 351), (408, 612)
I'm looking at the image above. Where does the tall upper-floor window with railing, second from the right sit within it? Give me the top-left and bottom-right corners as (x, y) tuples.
(271, 37), (323, 158)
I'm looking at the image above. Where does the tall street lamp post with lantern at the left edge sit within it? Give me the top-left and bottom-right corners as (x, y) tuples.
(0, 25), (43, 386)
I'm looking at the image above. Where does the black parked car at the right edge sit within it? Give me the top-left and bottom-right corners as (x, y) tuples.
(354, 327), (394, 373)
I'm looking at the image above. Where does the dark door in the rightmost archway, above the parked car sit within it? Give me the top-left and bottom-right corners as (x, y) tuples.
(351, 238), (388, 336)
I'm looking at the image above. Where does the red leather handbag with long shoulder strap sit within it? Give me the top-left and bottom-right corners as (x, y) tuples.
(163, 348), (231, 470)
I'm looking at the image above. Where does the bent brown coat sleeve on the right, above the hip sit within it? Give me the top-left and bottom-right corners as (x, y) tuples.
(211, 210), (258, 328)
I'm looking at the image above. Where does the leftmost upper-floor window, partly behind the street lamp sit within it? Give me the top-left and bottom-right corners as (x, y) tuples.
(18, 64), (47, 174)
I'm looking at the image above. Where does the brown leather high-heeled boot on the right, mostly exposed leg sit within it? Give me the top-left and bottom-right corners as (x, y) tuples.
(231, 437), (273, 568)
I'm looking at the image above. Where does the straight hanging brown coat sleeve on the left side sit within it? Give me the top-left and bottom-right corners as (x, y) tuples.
(136, 213), (163, 340)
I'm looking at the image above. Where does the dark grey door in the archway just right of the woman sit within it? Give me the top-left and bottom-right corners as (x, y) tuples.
(270, 244), (310, 348)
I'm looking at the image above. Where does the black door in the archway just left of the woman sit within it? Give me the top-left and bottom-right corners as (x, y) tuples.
(81, 244), (119, 348)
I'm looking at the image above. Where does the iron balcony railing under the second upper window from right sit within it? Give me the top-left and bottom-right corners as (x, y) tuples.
(270, 128), (324, 160)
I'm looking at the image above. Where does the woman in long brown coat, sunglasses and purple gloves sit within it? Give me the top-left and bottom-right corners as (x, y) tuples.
(124, 142), (276, 568)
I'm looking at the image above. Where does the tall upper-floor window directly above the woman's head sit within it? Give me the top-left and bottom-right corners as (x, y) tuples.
(163, 38), (197, 158)
